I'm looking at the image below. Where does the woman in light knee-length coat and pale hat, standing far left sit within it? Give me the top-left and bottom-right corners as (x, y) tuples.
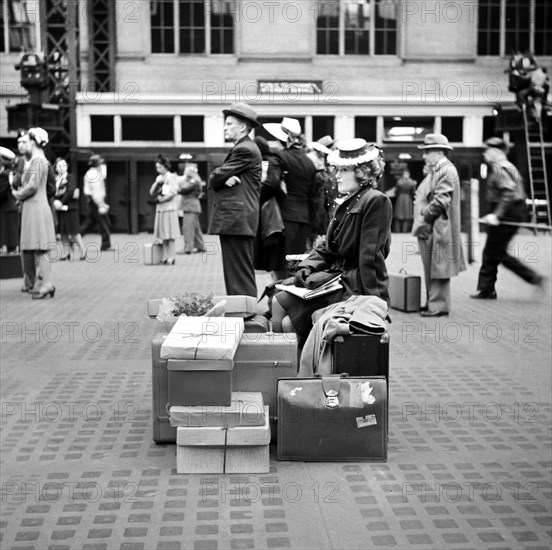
(12, 128), (56, 300)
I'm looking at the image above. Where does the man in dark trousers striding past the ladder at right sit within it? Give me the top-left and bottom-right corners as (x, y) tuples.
(470, 137), (544, 300)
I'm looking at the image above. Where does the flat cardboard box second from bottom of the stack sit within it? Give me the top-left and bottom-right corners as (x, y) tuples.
(169, 392), (265, 428)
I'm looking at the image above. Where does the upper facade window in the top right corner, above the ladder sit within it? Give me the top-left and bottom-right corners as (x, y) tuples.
(477, 0), (552, 56)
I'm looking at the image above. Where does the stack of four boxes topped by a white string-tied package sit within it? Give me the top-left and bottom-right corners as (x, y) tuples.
(160, 317), (270, 474)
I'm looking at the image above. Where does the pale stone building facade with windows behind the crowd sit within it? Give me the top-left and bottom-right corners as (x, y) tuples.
(0, 0), (552, 232)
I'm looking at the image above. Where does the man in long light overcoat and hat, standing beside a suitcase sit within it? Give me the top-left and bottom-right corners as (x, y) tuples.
(416, 134), (466, 317)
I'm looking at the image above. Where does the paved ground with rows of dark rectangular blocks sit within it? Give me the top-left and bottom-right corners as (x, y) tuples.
(0, 233), (552, 550)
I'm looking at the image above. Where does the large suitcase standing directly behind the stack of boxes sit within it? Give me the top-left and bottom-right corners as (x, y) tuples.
(152, 333), (297, 443)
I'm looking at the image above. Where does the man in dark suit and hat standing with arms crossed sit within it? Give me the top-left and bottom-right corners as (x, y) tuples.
(209, 103), (262, 298)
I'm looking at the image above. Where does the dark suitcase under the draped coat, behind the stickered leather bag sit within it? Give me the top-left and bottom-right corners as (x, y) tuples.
(332, 332), (389, 384)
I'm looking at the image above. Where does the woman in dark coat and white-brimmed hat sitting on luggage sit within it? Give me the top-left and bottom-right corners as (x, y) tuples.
(272, 139), (393, 349)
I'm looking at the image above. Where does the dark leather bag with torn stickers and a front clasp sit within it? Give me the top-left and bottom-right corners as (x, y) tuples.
(277, 375), (387, 462)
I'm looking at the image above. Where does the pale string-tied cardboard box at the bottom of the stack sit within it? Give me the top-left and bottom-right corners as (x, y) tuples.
(176, 407), (270, 474)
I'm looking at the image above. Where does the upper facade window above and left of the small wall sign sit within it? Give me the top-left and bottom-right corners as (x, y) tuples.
(150, 0), (236, 54)
